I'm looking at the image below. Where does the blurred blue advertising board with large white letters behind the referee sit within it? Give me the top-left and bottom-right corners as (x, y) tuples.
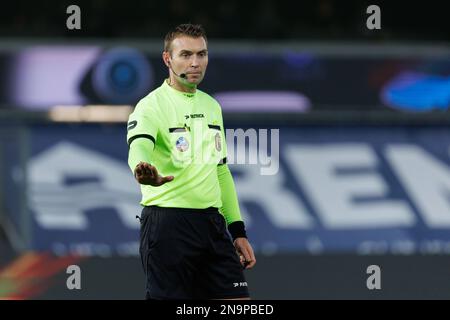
(6, 125), (450, 256)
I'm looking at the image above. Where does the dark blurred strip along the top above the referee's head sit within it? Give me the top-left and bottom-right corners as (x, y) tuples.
(0, 0), (450, 41)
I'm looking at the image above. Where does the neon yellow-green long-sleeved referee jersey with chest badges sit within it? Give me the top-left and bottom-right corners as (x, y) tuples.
(127, 80), (242, 228)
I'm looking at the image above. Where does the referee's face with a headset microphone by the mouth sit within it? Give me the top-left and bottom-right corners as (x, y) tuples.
(163, 36), (208, 86)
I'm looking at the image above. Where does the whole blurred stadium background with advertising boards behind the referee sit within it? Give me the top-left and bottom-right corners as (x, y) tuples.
(0, 0), (450, 299)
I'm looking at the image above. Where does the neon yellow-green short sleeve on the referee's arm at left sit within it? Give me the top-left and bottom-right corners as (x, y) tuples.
(127, 99), (160, 145)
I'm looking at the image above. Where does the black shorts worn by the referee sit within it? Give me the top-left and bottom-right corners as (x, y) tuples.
(139, 206), (249, 299)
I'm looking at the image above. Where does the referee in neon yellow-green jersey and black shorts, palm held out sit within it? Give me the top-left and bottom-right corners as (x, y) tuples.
(127, 24), (256, 299)
